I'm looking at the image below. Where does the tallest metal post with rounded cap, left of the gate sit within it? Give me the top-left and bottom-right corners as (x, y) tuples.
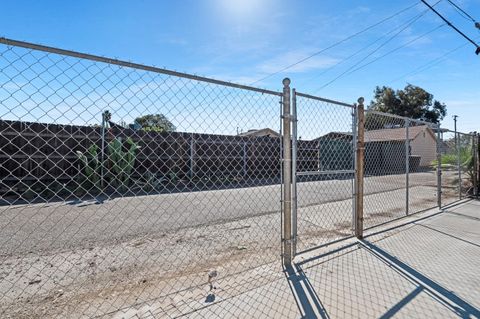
(282, 78), (292, 267)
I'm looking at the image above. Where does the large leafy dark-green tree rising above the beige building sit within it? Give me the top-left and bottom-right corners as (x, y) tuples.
(366, 84), (447, 129)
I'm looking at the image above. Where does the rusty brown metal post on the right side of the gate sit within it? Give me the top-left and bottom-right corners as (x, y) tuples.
(355, 97), (365, 239)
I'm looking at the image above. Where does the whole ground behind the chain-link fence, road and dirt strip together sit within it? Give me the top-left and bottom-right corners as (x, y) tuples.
(0, 172), (458, 318)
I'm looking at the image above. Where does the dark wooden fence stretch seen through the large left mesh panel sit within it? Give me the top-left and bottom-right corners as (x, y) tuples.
(0, 121), (280, 200)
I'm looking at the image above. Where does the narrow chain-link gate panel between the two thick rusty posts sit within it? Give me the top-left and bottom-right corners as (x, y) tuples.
(292, 90), (356, 255)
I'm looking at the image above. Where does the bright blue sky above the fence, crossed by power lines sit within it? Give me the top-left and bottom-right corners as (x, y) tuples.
(0, 0), (480, 131)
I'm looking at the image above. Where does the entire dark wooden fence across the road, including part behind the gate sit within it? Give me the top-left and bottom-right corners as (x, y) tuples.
(0, 120), (352, 199)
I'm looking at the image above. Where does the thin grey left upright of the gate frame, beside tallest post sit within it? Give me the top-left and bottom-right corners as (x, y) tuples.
(292, 89), (298, 257)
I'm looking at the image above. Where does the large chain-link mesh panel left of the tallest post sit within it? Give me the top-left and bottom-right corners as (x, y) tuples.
(0, 38), (294, 318)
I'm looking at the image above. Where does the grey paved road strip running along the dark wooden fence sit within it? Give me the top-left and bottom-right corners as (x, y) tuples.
(0, 173), (442, 255)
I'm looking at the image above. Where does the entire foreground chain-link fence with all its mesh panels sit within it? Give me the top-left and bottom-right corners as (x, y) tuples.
(0, 38), (478, 318)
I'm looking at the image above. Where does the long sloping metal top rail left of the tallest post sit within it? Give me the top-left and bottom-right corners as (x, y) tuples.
(0, 37), (282, 96)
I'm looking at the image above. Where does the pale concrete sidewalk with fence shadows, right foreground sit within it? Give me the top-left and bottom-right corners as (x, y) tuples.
(172, 201), (480, 318)
